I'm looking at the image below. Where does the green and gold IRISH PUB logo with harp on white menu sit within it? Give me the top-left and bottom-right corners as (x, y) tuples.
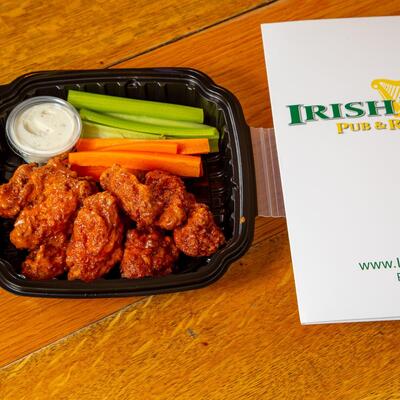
(286, 79), (400, 133)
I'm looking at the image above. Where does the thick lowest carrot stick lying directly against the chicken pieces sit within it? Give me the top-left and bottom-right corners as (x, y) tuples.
(69, 151), (202, 177)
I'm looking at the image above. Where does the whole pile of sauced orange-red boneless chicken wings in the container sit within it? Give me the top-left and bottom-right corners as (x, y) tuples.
(0, 152), (225, 282)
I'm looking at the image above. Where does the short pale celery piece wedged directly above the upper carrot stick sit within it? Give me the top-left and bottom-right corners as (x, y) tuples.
(81, 121), (165, 140)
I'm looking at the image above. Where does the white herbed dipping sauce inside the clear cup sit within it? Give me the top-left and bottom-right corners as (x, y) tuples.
(13, 103), (77, 154)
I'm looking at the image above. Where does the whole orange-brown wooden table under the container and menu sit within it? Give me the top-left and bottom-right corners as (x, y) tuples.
(0, 0), (400, 400)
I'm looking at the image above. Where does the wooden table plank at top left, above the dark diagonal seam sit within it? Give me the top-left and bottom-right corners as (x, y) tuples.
(0, 0), (271, 82)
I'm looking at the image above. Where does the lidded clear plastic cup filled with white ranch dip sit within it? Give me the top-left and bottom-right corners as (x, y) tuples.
(6, 96), (82, 163)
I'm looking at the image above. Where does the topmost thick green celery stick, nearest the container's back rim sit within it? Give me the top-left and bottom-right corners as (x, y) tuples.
(68, 90), (204, 123)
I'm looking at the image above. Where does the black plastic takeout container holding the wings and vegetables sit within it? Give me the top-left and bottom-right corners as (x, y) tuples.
(0, 68), (257, 297)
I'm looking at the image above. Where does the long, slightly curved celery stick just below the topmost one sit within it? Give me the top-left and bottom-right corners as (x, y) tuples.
(80, 109), (218, 138)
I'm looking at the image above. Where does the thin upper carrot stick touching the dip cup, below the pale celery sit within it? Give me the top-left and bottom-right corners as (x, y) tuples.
(76, 139), (178, 154)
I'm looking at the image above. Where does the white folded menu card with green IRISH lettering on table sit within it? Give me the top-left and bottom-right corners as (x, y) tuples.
(262, 17), (400, 324)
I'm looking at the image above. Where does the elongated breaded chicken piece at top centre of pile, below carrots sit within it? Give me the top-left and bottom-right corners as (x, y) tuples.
(100, 165), (159, 228)
